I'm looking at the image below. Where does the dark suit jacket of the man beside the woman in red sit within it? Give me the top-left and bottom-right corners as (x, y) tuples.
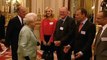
(54, 16), (76, 46)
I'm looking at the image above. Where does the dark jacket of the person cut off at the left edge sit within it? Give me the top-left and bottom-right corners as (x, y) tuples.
(0, 15), (5, 39)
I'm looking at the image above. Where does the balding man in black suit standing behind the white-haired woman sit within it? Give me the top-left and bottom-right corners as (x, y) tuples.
(6, 6), (26, 60)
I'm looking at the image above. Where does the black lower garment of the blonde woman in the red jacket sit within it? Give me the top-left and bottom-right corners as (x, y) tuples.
(41, 35), (54, 60)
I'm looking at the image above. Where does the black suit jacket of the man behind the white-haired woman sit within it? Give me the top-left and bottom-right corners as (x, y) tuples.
(6, 16), (23, 48)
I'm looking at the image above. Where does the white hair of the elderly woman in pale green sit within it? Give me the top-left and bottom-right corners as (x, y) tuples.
(23, 13), (37, 24)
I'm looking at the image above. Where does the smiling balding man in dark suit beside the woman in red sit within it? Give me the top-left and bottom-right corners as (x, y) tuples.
(54, 7), (75, 60)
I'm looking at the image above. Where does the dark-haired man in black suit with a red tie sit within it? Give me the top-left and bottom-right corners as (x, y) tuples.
(74, 8), (96, 60)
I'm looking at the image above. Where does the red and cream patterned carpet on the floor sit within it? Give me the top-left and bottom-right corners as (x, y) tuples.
(0, 43), (57, 60)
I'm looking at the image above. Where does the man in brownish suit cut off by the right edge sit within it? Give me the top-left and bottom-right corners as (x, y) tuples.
(94, 11), (107, 60)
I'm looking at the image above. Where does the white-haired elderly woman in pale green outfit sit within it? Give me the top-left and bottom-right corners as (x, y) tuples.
(18, 13), (38, 60)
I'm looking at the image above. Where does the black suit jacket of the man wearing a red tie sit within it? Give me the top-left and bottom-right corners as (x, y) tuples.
(74, 20), (96, 57)
